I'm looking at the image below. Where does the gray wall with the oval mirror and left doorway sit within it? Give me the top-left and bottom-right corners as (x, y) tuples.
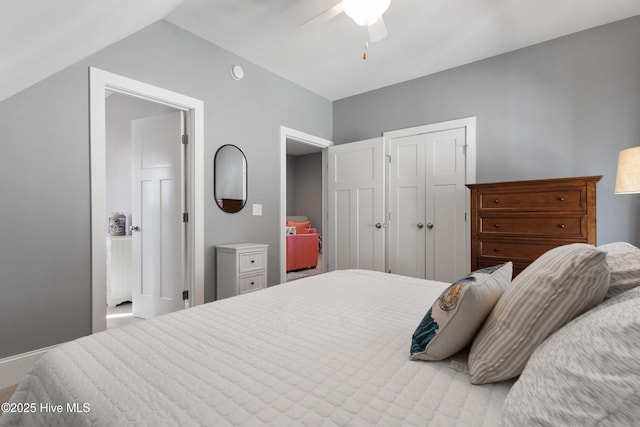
(0, 21), (332, 358)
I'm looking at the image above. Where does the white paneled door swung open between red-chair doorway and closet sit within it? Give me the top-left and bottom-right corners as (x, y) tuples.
(327, 138), (385, 271)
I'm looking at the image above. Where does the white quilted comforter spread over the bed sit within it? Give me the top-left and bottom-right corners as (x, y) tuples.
(0, 270), (511, 427)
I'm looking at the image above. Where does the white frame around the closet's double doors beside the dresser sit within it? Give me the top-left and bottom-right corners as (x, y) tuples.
(382, 116), (476, 271)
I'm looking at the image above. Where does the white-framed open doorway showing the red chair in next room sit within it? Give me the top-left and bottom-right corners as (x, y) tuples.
(280, 127), (333, 283)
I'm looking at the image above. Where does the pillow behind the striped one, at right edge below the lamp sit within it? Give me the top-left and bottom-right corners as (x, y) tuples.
(598, 242), (640, 299)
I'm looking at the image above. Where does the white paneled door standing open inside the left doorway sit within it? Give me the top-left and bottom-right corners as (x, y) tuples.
(131, 111), (185, 318)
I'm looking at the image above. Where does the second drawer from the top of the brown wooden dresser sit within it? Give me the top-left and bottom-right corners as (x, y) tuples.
(478, 214), (587, 239)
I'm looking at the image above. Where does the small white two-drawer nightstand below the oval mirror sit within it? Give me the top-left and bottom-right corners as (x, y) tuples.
(216, 243), (269, 299)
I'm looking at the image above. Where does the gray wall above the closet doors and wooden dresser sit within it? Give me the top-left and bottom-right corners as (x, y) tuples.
(333, 16), (640, 245)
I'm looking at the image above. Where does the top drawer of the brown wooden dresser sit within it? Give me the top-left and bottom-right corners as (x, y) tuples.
(478, 186), (586, 211)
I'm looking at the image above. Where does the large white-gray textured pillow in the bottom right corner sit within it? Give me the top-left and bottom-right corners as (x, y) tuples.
(502, 288), (640, 427)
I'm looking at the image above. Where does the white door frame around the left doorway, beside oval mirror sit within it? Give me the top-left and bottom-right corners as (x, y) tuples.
(89, 67), (204, 333)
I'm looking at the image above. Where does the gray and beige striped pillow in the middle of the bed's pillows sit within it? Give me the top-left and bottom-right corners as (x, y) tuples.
(469, 243), (609, 384)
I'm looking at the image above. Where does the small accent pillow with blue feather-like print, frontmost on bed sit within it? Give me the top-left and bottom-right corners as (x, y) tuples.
(411, 262), (513, 360)
